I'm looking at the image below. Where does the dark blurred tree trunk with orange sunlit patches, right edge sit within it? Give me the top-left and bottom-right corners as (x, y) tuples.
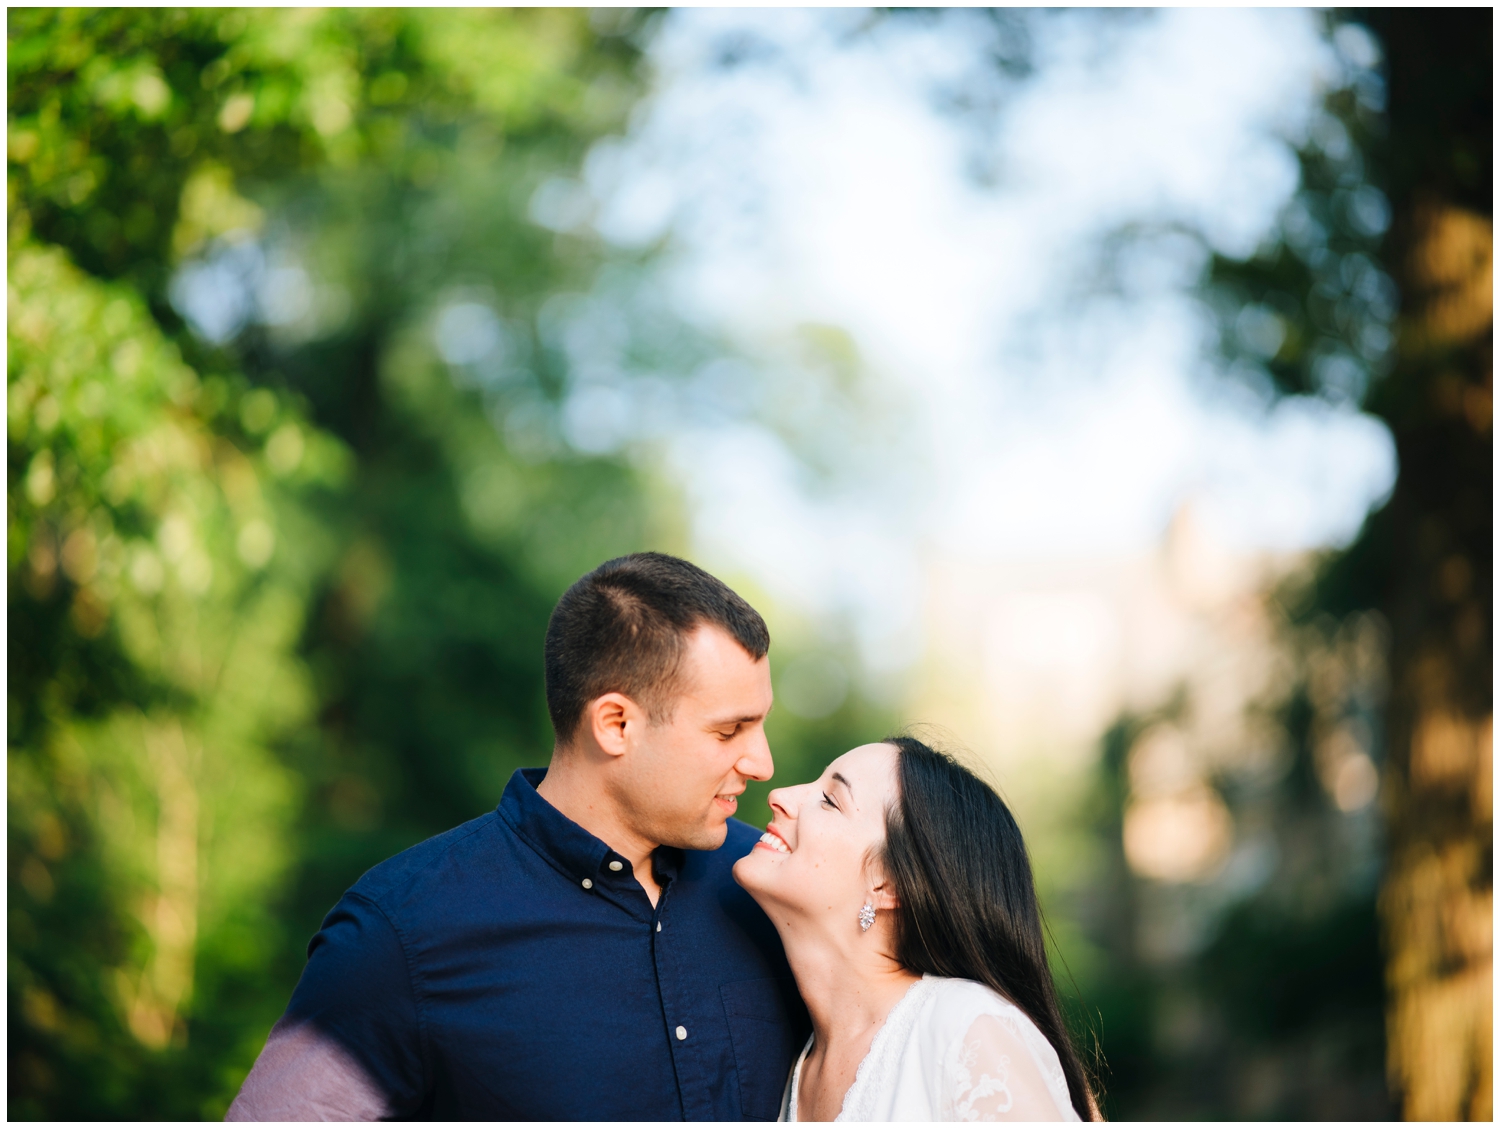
(1365, 9), (1494, 1120)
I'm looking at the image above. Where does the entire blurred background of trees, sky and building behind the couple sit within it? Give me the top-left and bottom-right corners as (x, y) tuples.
(9, 9), (1493, 1119)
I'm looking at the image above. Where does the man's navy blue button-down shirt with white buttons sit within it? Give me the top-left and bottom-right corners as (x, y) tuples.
(231, 769), (809, 1120)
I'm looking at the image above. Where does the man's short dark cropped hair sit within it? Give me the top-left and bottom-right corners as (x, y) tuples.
(545, 553), (771, 745)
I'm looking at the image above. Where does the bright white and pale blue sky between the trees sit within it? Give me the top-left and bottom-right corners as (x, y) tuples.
(588, 9), (1395, 663)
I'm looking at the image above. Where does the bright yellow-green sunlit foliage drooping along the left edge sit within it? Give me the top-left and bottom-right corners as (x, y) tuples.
(9, 230), (344, 1114)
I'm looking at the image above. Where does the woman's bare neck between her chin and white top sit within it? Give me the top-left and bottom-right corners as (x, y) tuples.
(773, 915), (921, 1057)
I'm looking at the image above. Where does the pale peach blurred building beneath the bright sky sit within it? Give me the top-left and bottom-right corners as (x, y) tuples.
(912, 504), (1307, 763)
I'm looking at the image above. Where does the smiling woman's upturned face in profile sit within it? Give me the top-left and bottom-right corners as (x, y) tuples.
(735, 745), (899, 930)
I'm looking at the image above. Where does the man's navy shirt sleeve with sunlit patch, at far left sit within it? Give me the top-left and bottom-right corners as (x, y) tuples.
(225, 894), (426, 1122)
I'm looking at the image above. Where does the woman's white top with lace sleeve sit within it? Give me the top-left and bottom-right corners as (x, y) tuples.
(782, 976), (1079, 1122)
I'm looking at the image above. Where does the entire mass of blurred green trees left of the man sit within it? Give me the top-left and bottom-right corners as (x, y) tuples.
(8, 9), (669, 1119)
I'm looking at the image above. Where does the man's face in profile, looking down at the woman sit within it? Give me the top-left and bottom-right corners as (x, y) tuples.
(620, 625), (773, 850)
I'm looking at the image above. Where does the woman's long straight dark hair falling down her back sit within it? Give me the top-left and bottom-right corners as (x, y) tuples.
(881, 738), (1095, 1122)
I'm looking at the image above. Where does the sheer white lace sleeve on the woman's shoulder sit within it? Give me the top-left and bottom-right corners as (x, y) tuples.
(945, 1014), (1076, 1122)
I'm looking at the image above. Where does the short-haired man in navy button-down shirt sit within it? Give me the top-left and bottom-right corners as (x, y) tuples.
(228, 553), (809, 1120)
